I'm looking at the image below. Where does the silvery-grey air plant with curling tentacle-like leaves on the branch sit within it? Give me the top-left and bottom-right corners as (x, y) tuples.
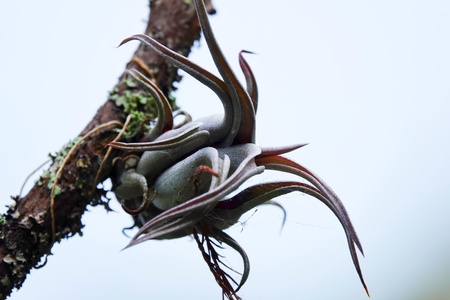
(109, 0), (368, 299)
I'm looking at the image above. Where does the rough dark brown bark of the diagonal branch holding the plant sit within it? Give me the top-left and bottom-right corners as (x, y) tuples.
(0, 0), (212, 299)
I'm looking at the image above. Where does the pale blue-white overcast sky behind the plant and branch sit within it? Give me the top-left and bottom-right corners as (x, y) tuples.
(0, 0), (450, 300)
